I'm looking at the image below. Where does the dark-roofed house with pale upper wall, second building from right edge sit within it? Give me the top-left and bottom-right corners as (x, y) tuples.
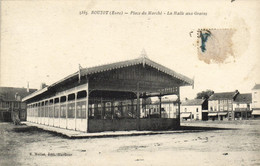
(233, 93), (252, 120)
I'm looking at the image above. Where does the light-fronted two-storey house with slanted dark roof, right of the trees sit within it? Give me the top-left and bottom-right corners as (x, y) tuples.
(208, 90), (239, 120)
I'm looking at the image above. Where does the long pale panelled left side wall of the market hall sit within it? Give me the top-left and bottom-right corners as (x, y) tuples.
(27, 84), (89, 132)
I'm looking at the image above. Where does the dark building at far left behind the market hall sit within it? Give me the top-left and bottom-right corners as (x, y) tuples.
(0, 87), (37, 122)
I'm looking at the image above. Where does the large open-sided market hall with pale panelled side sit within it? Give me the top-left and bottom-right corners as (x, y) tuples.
(23, 56), (193, 132)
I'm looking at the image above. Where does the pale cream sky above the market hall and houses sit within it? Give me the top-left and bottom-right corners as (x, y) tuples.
(0, 0), (260, 98)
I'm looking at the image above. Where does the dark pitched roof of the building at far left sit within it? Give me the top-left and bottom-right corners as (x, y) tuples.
(0, 87), (37, 101)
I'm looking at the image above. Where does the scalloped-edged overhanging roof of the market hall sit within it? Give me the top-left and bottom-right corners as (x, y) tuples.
(23, 56), (194, 101)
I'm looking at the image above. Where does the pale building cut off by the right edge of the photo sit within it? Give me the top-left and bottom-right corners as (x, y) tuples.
(252, 84), (260, 118)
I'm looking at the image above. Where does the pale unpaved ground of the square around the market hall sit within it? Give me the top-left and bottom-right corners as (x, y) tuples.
(0, 120), (260, 166)
